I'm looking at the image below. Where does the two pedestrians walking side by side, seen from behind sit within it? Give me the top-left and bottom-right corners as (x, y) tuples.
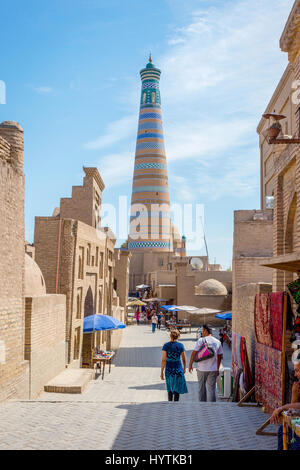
(161, 325), (223, 402)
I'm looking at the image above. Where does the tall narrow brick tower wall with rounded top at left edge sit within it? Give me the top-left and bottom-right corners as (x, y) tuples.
(0, 122), (28, 401)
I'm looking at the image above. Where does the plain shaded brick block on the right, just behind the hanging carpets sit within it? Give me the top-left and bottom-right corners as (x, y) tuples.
(232, 209), (273, 369)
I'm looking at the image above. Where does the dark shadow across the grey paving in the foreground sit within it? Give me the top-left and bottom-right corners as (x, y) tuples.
(112, 401), (277, 450)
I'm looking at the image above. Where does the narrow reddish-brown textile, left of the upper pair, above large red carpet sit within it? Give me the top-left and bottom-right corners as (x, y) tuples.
(254, 294), (272, 347)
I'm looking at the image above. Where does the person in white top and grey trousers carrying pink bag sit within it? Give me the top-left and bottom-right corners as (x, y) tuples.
(189, 325), (223, 402)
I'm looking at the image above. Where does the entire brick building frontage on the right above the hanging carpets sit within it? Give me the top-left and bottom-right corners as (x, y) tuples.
(232, 0), (300, 374)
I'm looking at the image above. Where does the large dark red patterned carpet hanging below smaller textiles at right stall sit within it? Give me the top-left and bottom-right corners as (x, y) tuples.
(255, 343), (282, 413)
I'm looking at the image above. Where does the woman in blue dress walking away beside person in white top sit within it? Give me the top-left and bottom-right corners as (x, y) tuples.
(160, 330), (188, 401)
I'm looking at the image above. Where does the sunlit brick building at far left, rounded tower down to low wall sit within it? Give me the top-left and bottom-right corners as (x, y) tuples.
(0, 121), (66, 401)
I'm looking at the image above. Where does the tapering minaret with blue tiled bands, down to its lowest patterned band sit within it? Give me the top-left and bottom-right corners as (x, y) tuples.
(128, 55), (172, 251)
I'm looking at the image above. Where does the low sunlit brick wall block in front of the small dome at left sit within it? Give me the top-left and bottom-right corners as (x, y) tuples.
(25, 294), (66, 398)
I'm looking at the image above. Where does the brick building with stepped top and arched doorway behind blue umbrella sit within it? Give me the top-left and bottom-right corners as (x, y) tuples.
(34, 168), (124, 367)
